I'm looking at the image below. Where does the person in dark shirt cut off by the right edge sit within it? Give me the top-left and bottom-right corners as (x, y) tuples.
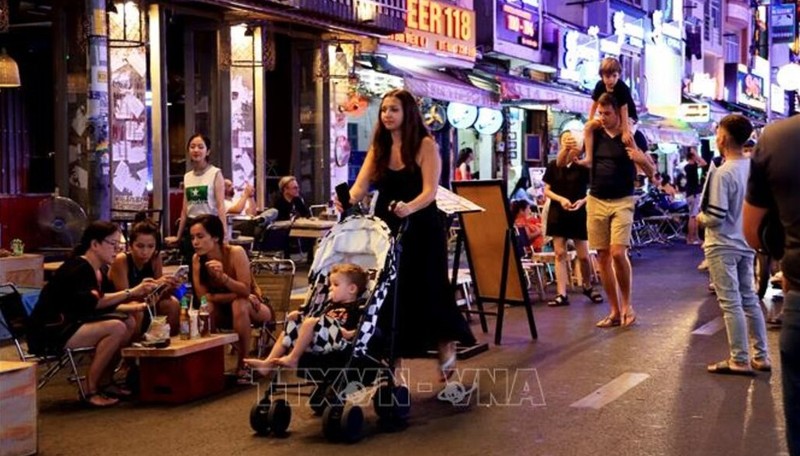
(744, 115), (800, 455)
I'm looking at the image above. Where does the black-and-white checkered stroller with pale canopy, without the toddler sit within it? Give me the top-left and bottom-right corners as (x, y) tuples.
(250, 215), (410, 442)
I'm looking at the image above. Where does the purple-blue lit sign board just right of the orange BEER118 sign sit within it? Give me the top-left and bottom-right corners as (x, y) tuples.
(495, 0), (540, 49)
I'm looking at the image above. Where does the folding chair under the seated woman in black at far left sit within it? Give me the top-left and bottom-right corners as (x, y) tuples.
(0, 283), (94, 399)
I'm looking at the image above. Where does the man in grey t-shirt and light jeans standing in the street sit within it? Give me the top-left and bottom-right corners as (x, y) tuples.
(697, 114), (771, 374)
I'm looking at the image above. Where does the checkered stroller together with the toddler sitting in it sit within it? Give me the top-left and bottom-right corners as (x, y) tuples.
(245, 215), (410, 442)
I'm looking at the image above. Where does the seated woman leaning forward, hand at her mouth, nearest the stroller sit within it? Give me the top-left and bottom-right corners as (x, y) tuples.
(189, 215), (273, 382)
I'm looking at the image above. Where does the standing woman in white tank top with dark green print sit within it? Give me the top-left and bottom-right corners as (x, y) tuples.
(172, 133), (226, 258)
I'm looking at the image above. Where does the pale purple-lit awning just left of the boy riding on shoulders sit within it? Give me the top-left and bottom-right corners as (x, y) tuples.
(495, 76), (592, 114)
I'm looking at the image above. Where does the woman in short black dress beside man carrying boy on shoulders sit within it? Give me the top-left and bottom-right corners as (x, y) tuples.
(543, 130), (603, 307)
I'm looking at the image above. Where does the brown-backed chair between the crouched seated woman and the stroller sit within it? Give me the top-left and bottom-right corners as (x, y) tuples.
(250, 258), (297, 358)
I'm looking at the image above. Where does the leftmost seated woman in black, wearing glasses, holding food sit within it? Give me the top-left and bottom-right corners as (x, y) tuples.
(28, 222), (156, 407)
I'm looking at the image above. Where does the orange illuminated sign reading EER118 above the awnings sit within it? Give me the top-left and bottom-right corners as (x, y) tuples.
(381, 0), (476, 62)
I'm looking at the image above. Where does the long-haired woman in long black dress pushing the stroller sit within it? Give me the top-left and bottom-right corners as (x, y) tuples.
(350, 89), (475, 381)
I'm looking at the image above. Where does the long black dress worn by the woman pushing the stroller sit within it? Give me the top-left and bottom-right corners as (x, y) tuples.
(375, 167), (475, 358)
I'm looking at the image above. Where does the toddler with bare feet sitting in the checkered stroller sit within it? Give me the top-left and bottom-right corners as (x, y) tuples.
(244, 263), (368, 376)
